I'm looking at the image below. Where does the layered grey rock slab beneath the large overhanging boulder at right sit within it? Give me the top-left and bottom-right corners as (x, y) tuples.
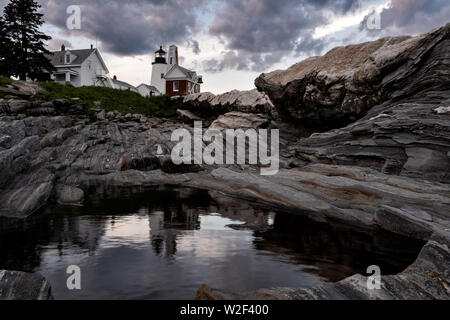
(289, 99), (450, 183)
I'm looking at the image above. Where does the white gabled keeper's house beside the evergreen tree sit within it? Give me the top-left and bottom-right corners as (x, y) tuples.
(49, 45), (114, 88)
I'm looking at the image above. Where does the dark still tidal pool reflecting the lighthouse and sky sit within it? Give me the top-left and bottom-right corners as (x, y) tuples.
(0, 189), (424, 299)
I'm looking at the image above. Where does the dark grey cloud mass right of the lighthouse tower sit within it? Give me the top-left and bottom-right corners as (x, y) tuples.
(205, 0), (359, 71)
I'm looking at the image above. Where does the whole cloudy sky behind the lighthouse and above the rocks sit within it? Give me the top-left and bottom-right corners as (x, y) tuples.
(0, 0), (450, 93)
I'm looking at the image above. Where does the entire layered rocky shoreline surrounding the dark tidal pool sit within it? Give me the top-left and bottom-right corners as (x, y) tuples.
(0, 24), (450, 299)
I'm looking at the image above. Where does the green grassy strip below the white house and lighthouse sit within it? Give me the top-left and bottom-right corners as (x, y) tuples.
(39, 82), (181, 117)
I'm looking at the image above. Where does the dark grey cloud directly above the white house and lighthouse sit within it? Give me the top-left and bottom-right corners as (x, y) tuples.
(9, 0), (207, 55)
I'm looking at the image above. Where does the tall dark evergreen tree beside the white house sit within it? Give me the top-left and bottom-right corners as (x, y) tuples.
(4, 0), (54, 80)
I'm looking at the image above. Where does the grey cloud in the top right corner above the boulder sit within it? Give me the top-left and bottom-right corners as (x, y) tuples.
(360, 0), (450, 36)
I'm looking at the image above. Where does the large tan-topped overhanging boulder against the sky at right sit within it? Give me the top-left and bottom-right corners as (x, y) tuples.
(255, 24), (450, 130)
